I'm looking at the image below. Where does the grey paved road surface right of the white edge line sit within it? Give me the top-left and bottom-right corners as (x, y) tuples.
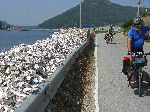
(97, 34), (150, 112)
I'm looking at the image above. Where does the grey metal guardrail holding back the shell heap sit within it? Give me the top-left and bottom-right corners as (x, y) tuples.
(15, 31), (90, 112)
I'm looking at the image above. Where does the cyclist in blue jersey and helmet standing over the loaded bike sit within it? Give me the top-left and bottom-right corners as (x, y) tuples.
(127, 17), (150, 61)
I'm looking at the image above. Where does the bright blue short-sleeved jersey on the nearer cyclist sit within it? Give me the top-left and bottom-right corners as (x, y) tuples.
(128, 26), (150, 48)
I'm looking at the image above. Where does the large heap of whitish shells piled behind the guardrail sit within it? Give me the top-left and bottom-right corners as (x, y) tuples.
(0, 28), (87, 112)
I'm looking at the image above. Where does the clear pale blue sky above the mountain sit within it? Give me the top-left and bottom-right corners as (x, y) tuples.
(0, 0), (150, 26)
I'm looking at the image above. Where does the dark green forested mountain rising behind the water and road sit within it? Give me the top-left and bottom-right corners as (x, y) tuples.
(39, 0), (148, 28)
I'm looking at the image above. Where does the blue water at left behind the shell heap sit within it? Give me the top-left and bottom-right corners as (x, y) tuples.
(0, 30), (54, 52)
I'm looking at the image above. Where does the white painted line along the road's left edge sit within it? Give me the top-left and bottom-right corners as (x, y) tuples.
(94, 37), (99, 112)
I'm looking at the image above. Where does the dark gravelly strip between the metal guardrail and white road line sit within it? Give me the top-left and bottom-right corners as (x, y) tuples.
(46, 32), (95, 112)
